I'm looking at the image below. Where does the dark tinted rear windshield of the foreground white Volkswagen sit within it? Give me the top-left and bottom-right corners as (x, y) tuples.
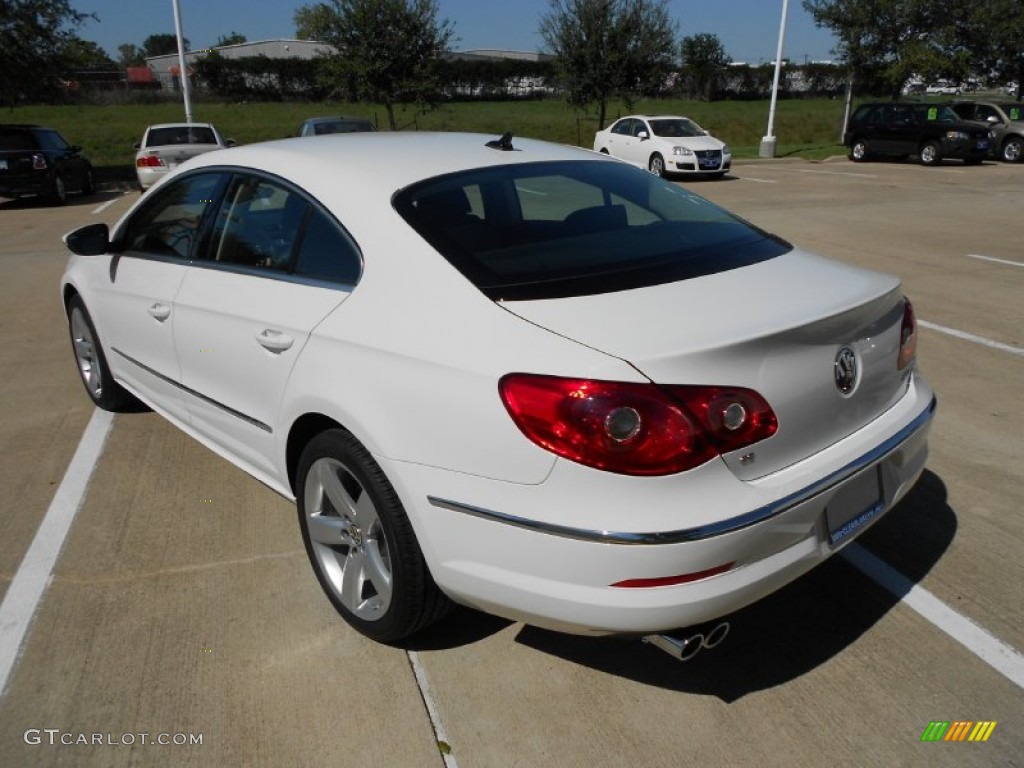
(393, 161), (791, 300)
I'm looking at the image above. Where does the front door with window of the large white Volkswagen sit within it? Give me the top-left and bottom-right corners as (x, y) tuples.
(89, 173), (225, 422)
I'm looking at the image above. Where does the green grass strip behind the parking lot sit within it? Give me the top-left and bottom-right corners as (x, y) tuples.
(0, 93), (958, 180)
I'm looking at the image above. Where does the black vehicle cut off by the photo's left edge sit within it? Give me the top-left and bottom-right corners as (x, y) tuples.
(0, 125), (96, 205)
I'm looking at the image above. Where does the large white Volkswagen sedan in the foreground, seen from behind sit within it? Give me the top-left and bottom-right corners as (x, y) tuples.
(60, 132), (935, 642)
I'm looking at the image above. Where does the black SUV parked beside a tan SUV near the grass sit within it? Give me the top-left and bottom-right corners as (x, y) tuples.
(843, 101), (992, 165)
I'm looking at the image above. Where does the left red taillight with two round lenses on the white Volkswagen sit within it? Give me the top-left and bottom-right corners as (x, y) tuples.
(498, 374), (777, 475)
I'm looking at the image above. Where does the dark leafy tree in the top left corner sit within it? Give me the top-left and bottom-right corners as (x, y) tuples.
(0, 0), (95, 105)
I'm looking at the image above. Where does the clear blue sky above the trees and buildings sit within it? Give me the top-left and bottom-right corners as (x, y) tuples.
(72, 0), (836, 63)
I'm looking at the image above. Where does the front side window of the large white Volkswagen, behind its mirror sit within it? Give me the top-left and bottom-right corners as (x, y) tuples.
(117, 173), (224, 259)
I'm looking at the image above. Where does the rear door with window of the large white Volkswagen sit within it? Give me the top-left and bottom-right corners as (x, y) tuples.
(174, 173), (361, 477)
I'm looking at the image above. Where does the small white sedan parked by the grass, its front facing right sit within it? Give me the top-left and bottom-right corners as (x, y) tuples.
(594, 115), (732, 178)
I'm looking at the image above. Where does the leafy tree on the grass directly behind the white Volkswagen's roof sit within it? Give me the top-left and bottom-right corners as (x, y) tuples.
(295, 0), (455, 130)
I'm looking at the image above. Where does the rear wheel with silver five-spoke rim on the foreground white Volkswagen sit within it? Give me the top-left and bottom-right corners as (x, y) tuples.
(295, 429), (452, 643)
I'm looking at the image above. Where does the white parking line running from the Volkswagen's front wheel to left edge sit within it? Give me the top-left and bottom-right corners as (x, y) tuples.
(0, 409), (114, 697)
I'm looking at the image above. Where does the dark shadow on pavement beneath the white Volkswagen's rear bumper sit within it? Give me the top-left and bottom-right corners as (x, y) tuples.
(516, 471), (956, 701)
